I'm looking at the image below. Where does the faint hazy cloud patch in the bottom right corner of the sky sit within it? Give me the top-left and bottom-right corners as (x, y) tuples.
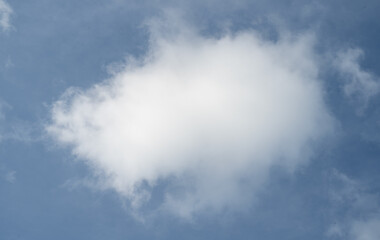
(327, 170), (380, 240)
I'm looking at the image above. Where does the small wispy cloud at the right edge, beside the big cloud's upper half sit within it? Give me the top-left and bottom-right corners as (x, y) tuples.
(335, 48), (380, 110)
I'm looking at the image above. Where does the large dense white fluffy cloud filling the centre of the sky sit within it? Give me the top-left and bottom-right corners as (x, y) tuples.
(46, 19), (332, 218)
